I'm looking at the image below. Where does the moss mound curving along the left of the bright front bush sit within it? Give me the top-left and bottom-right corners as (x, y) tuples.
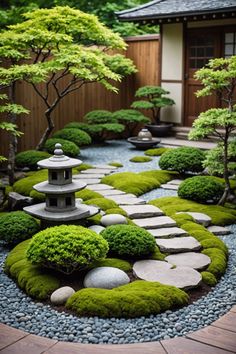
(4, 240), (60, 300)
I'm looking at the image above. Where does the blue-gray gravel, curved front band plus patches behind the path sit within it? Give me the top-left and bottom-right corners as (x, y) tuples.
(0, 142), (236, 344)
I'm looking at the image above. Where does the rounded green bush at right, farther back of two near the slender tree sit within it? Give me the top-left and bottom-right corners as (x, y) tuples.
(159, 147), (205, 173)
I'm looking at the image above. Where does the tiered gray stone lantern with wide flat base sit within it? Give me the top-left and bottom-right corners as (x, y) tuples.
(24, 144), (99, 227)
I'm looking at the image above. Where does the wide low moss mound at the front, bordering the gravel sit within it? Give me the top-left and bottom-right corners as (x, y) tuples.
(66, 280), (188, 318)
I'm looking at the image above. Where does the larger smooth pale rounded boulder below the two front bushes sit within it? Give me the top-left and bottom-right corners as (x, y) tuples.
(84, 267), (130, 289)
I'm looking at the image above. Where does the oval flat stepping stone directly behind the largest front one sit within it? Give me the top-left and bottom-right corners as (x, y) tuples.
(165, 252), (211, 269)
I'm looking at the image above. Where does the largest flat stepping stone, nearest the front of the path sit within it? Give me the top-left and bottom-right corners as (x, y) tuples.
(133, 260), (202, 290)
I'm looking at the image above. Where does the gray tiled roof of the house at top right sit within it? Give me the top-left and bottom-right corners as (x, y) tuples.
(116, 0), (236, 21)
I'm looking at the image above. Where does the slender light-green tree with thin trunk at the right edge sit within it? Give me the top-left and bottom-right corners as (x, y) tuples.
(189, 56), (236, 205)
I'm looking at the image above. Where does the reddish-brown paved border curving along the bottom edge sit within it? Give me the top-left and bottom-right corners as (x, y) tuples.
(0, 306), (236, 354)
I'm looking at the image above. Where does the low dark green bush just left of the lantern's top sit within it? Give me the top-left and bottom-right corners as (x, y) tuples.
(16, 150), (51, 170)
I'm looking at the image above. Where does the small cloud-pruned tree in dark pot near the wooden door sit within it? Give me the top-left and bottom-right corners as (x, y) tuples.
(131, 86), (175, 125)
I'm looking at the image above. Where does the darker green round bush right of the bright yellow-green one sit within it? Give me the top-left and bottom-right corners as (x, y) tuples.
(101, 225), (156, 257)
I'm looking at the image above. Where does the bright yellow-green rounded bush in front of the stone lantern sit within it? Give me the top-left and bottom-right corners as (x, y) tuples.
(27, 225), (108, 274)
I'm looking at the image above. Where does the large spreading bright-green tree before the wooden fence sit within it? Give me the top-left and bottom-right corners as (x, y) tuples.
(0, 6), (136, 150)
